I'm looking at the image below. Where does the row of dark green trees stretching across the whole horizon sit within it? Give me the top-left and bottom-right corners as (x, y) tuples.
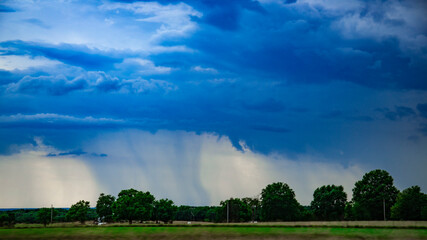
(0, 169), (427, 226)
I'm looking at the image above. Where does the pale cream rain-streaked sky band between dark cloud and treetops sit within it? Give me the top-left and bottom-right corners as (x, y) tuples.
(0, 130), (364, 207)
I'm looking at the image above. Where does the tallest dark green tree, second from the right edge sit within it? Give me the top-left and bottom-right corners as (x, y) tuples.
(353, 169), (399, 220)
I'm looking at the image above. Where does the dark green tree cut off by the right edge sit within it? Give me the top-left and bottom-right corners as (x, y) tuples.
(391, 186), (427, 220)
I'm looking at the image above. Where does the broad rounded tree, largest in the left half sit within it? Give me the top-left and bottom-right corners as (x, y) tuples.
(113, 188), (154, 224)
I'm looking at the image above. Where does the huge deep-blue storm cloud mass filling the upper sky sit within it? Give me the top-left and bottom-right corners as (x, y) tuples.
(0, 0), (427, 164)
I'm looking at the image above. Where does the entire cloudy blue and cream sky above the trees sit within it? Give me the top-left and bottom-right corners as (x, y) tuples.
(0, 0), (427, 208)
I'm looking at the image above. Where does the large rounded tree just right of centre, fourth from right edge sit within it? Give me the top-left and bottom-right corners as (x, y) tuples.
(261, 182), (301, 221)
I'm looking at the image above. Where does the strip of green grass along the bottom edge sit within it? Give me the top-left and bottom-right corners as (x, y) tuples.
(0, 227), (427, 240)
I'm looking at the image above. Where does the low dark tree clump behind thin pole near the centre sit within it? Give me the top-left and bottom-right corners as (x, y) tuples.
(220, 198), (252, 222)
